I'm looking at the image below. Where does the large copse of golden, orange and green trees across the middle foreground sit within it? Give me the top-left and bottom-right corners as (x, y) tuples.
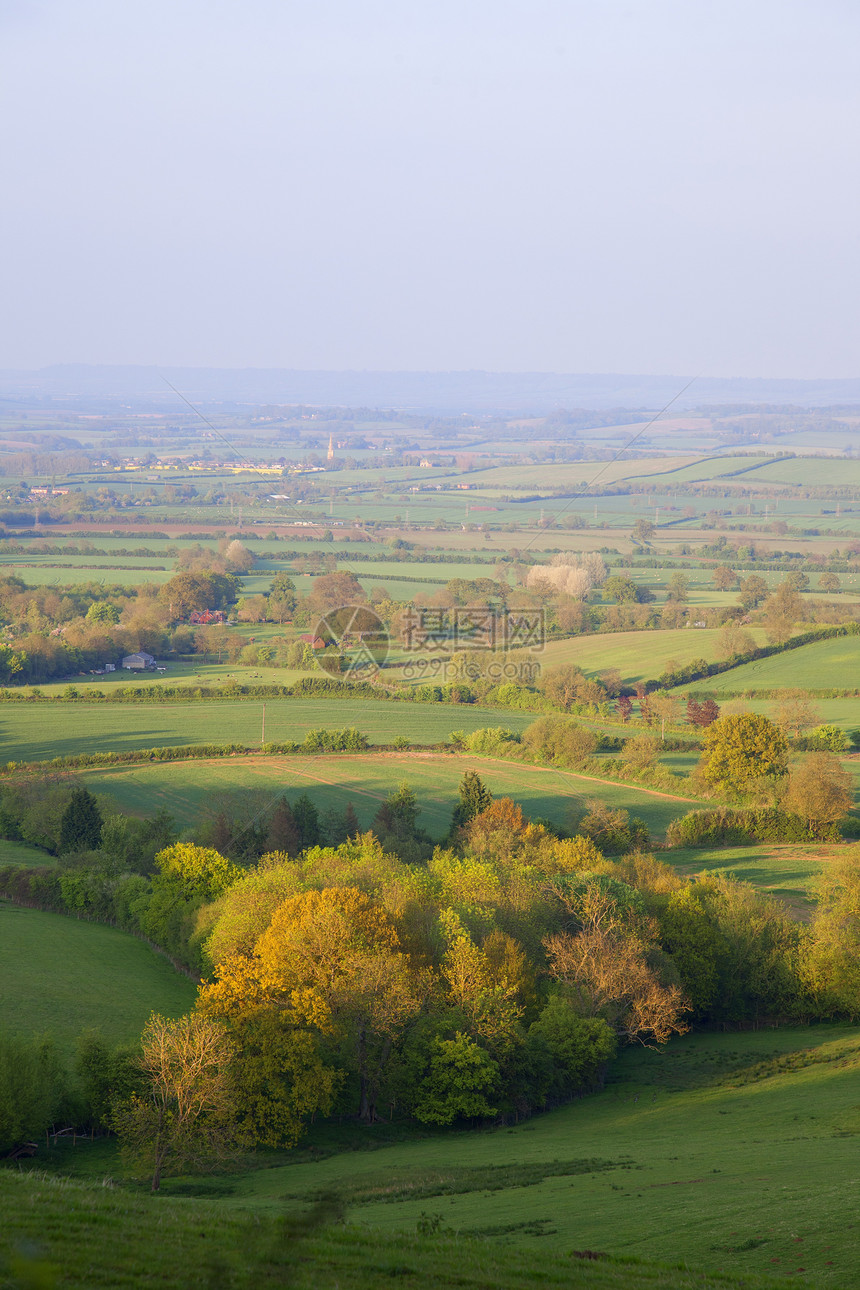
(8, 768), (860, 1187)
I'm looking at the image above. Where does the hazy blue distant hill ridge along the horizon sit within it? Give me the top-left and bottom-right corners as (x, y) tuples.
(0, 364), (860, 415)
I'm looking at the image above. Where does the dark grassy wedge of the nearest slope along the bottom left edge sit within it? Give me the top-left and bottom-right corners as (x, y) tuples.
(0, 1174), (789, 1290)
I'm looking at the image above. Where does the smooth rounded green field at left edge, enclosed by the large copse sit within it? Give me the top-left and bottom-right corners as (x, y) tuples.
(0, 900), (196, 1051)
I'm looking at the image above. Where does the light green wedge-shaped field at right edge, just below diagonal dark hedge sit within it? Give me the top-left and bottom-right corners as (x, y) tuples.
(698, 636), (860, 694)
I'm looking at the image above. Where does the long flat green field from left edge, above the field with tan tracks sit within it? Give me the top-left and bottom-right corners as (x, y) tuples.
(0, 698), (535, 761)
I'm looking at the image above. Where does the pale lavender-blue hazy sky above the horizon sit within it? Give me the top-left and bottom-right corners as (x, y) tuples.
(0, 0), (860, 377)
